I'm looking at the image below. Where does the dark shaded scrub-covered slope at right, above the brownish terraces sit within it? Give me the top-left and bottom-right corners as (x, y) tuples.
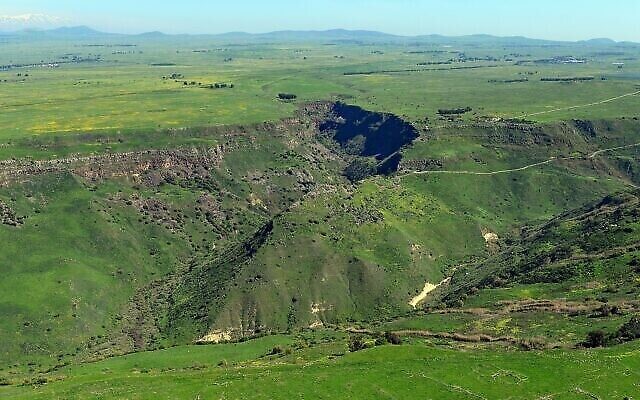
(442, 191), (640, 303)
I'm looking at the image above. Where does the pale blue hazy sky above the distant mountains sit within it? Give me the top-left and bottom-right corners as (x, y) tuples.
(0, 0), (640, 42)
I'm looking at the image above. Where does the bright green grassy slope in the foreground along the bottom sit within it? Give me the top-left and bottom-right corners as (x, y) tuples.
(0, 337), (640, 400)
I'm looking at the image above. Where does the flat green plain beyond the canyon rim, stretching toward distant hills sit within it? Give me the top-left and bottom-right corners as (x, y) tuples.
(0, 38), (640, 145)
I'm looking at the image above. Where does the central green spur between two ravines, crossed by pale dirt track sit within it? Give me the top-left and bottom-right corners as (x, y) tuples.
(196, 112), (637, 338)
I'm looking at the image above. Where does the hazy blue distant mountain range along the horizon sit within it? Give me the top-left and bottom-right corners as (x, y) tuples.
(0, 26), (638, 46)
